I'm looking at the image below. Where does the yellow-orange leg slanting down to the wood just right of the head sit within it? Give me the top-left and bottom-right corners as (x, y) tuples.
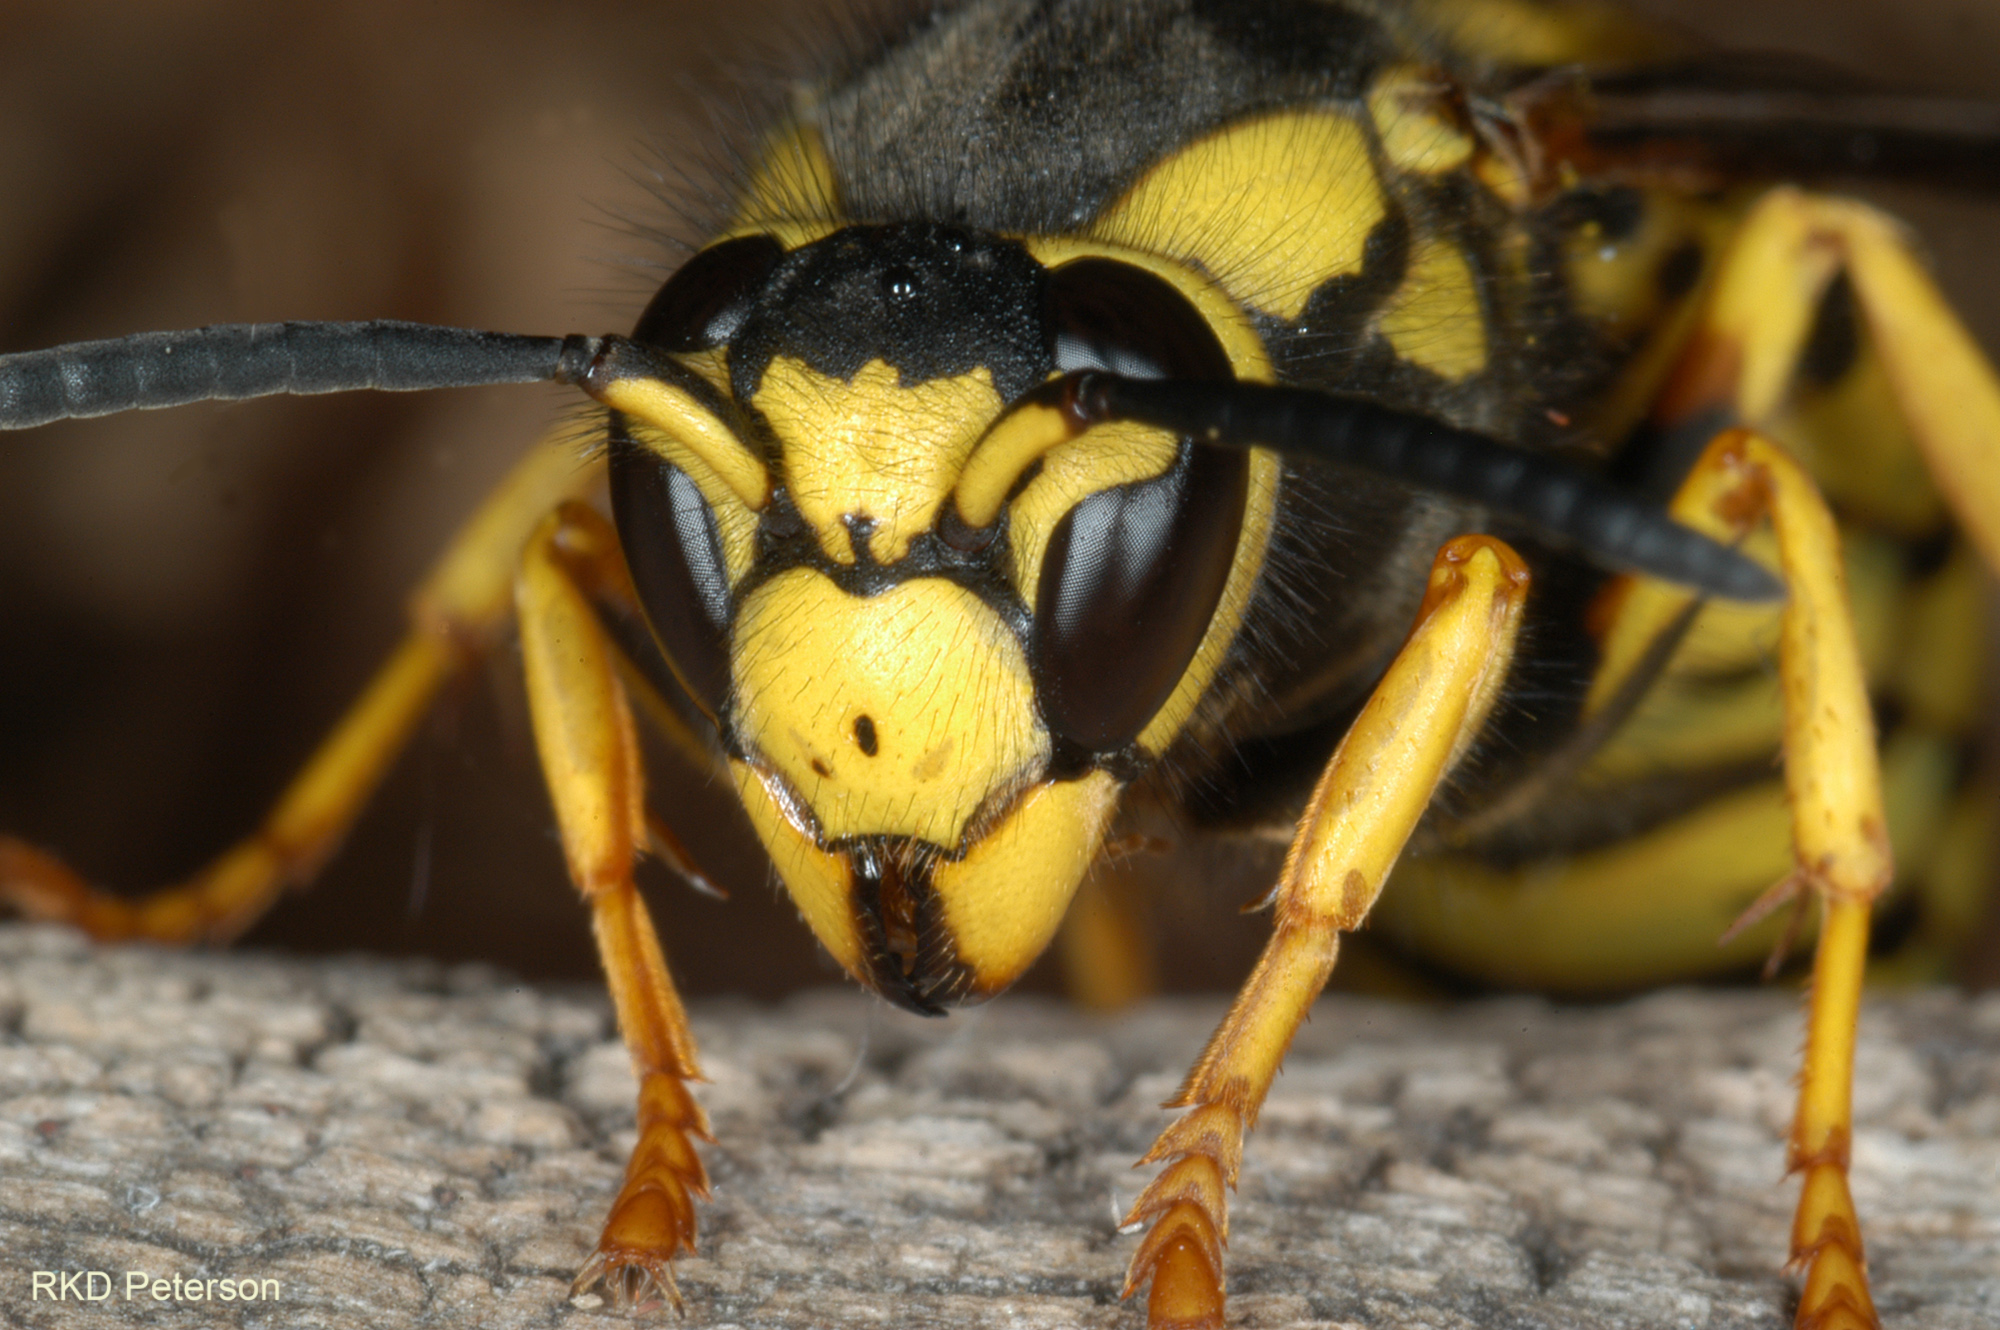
(1124, 536), (1528, 1330)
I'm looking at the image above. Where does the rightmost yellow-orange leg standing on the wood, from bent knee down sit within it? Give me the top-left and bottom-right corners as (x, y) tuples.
(1674, 430), (1894, 1330)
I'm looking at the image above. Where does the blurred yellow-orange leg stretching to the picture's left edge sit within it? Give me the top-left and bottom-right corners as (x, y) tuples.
(0, 436), (598, 942)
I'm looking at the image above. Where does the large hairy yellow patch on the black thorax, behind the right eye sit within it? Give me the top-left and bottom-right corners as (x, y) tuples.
(1092, 110), (1388, 318)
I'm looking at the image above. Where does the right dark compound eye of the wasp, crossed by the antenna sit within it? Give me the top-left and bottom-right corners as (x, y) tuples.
(1032, 258), (1250, 754)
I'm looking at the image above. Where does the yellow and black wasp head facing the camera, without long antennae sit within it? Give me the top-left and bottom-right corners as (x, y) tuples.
(594, 224), (1254, 1012)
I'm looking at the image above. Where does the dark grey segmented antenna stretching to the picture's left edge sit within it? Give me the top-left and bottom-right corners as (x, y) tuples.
(0, 318), (600, 430)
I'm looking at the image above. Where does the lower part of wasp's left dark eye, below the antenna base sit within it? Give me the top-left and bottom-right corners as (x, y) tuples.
(610, 434), (730, 718)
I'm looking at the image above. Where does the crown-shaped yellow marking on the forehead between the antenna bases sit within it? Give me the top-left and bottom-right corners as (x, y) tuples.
(752, 356), (1004, 564)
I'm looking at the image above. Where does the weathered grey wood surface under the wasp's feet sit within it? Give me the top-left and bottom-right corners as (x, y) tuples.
(0, 928), (2000, 1330)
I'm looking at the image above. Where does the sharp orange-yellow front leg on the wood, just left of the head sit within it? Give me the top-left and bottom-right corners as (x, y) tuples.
(514, 504), (710, 1310)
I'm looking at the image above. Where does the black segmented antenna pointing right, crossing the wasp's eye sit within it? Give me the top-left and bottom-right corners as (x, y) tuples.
(1072, 372), (1784, 600)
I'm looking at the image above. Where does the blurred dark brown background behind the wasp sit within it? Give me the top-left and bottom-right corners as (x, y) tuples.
(0, 0), (2000, 996)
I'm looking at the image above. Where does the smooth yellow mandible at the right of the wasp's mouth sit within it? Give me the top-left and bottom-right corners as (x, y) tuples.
(932, 772), (1124, 992)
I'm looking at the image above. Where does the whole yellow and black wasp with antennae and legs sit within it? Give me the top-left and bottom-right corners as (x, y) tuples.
(0, 0), (2000, 1328)
